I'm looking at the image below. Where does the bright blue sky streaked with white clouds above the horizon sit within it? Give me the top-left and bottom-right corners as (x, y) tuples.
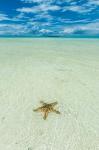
(0, 0), (99, 37)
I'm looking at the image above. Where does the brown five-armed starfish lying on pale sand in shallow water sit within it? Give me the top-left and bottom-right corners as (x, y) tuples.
(34, 101), (60, 120)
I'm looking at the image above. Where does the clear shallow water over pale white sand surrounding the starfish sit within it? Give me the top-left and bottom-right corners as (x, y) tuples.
(0, 38), (99, 150)
